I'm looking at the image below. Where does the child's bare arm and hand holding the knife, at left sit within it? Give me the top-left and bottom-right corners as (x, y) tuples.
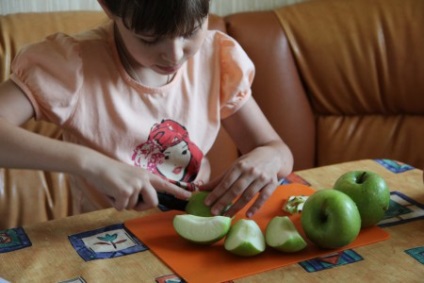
(0, 81), (190, 210)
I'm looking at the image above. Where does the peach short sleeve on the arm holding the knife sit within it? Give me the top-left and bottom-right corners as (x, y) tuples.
(11, 33), (83, 124)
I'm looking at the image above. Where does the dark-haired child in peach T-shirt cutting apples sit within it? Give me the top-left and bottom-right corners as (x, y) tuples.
(0, 0), (293, 220)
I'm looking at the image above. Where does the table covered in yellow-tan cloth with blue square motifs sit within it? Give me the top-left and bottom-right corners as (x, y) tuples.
(0, 160), (424, 283)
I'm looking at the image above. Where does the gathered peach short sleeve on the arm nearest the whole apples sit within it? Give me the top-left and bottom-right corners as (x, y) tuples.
(218, 34), (255, 119)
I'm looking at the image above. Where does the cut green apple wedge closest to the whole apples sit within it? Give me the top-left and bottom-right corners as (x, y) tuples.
(265, 216), (307, 253)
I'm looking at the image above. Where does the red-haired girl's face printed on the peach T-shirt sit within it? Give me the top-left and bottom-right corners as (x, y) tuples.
(132, 119), (203, 182)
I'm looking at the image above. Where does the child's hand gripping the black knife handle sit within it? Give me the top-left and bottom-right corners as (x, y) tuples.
(83, 158), (191, 210)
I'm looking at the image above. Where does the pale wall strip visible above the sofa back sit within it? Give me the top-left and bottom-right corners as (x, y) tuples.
(0, 0), (302, 16)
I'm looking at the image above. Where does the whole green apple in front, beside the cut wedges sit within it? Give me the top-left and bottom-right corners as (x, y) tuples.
(300, 189), (361, 249)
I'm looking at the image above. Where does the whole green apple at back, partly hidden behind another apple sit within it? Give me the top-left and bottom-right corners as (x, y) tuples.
(333, 171), (390, 228)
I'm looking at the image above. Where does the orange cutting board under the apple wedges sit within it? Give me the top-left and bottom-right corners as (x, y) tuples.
(125, 184), (389, 283)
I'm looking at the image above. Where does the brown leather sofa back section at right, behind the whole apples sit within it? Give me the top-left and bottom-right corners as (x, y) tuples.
(277, 0), (424, 168)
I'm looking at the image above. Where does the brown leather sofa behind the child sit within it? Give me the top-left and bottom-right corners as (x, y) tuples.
(0, 0), (424, 229)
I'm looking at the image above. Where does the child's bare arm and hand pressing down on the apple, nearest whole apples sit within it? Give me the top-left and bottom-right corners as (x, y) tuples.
(202, 98), (293, 217)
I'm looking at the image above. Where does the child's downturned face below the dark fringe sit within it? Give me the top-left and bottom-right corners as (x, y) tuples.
(116, 18), (208, 75)
